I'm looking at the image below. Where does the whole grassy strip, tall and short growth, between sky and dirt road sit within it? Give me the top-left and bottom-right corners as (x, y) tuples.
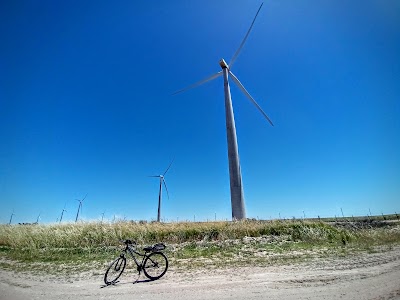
(0, 216), (400, 274)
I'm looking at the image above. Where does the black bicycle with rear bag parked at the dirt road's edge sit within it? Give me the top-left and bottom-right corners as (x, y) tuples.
(104, 240), (168, 285)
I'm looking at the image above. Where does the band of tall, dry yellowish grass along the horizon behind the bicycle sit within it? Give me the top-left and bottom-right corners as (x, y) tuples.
(0, 221), (350, 250)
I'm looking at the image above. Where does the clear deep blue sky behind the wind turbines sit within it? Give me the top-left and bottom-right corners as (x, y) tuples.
(0, 0), (400, 223)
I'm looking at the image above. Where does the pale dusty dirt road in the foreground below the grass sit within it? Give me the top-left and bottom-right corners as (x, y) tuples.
(0, 248), (400, 300)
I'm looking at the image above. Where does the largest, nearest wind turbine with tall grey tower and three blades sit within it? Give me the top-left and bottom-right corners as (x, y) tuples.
(174, 3), (274, 220)
